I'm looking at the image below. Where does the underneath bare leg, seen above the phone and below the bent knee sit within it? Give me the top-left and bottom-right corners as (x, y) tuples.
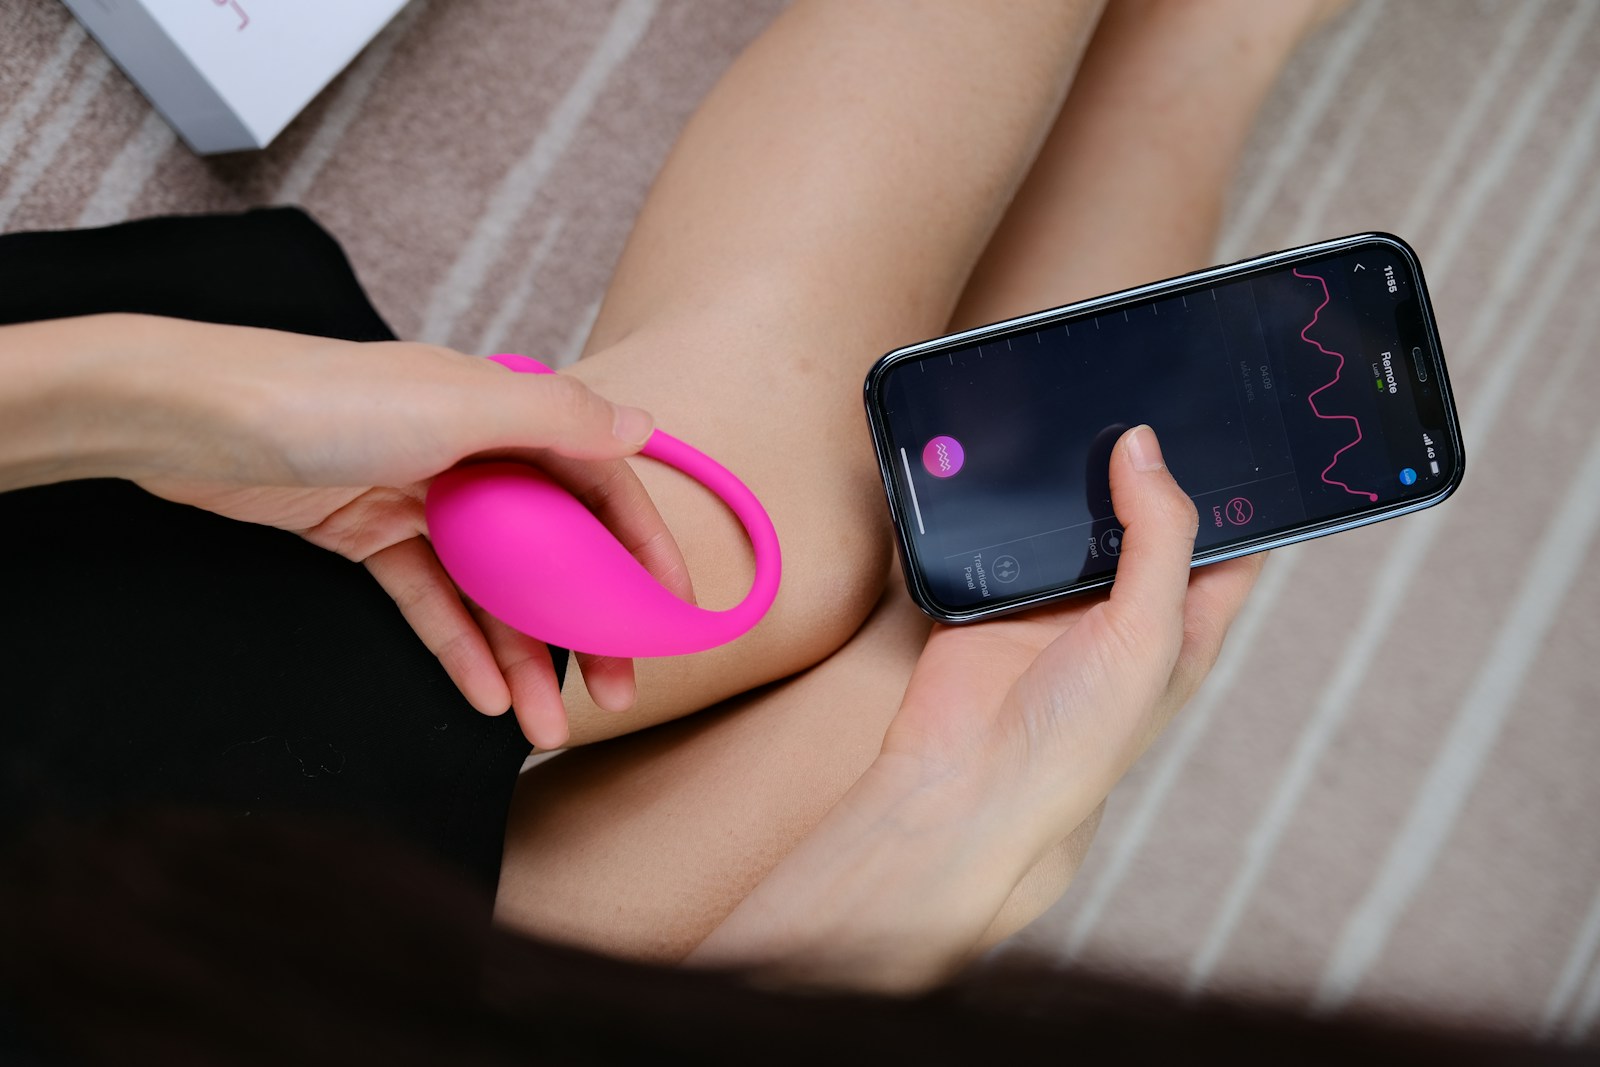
(499, 0), (1324, 960)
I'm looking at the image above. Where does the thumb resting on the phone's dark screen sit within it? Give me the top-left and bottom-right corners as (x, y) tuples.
(1110, 426), (1200, 637)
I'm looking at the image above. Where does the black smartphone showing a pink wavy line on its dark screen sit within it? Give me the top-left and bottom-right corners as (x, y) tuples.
(866, 234), (1464, 622)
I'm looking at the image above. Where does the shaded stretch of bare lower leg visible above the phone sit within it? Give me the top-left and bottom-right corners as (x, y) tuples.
(950, 0), (1341, 328)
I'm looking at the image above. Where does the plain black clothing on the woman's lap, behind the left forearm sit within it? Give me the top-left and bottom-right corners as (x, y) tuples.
(0, 208), (550, 891)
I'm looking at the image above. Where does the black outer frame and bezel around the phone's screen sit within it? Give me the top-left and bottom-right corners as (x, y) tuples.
(864, 230), (1466, 624)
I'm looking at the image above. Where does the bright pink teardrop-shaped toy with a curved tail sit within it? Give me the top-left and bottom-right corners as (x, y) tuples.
(427, 355), (782, 657)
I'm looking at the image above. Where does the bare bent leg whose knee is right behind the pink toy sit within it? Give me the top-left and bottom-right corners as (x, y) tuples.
(565, 0), (1098, 744)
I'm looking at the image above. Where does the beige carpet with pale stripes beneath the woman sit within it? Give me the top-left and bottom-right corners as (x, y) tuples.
(0, 0), (1600, 1040)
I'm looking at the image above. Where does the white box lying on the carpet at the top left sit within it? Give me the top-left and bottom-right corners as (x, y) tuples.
(64, 0), (406, 154)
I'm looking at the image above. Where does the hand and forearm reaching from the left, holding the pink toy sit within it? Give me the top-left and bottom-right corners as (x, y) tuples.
(0, 315), (691, 747)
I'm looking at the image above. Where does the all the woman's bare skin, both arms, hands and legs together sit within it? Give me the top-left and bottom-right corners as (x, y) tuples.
(0, 0), (1337, 989)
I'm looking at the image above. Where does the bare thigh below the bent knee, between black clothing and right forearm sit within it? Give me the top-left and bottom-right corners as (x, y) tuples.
(496, 566), (1098, 961)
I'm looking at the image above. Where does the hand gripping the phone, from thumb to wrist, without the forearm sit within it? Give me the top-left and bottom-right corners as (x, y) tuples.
(883, 426), (1264, 849)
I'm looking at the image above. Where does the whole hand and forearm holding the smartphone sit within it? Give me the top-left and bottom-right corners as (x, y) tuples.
(693, 427), (1262, 990)
